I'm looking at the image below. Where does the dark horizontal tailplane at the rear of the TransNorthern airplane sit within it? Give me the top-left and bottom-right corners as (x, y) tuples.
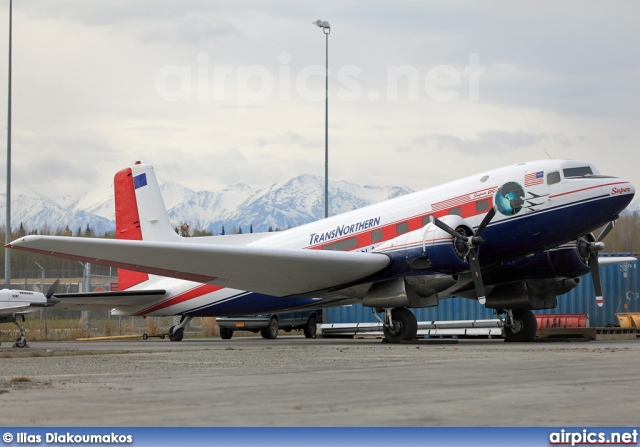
(53, 289), (167, 310)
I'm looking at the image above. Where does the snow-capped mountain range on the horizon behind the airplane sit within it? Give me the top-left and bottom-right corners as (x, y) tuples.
(0, 175), (412, 235)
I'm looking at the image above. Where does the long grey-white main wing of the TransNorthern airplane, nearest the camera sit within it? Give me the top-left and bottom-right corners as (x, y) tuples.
(7, 235), (390, 296)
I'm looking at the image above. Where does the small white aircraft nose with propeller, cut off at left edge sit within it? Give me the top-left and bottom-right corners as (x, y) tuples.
(0, 280), (60, 348)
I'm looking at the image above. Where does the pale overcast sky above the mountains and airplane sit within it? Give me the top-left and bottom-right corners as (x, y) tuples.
(0, 0), (640, 202)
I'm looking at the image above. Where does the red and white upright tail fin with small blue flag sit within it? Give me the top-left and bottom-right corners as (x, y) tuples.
(113, 162), (180, 290)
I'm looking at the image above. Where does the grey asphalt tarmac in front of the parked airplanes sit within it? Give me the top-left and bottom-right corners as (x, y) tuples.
(0, 336), (640, 427)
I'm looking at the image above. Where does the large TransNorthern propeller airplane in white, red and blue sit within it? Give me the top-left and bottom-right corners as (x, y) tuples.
(8, 160), (635, 343)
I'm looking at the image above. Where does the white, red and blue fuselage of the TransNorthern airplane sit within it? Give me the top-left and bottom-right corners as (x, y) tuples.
(115, 160), (635, 316)
